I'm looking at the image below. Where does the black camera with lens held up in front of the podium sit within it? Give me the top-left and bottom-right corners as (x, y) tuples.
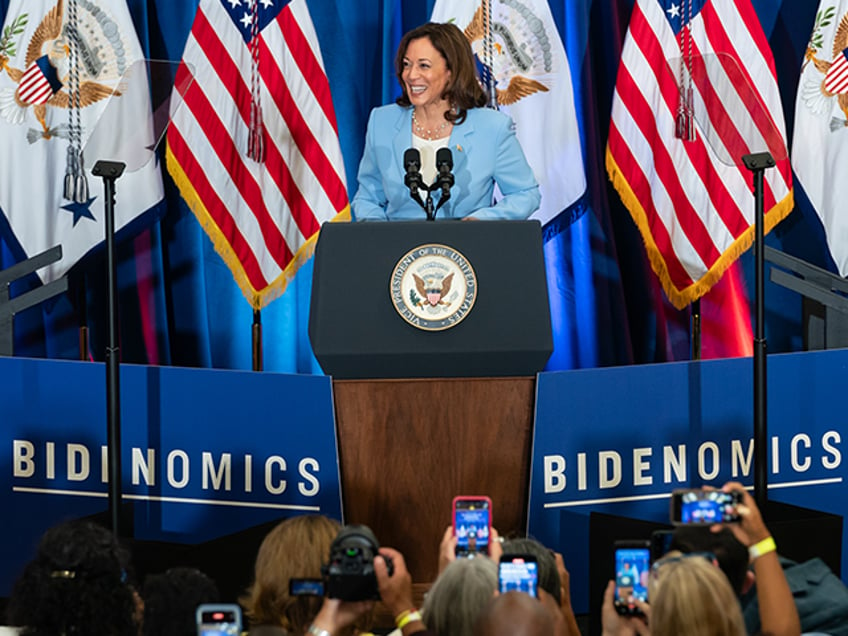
(321, 525), (394, 601)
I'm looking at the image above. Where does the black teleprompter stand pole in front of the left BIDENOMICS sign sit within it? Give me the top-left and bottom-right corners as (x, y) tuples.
(91, 161), (126, 537)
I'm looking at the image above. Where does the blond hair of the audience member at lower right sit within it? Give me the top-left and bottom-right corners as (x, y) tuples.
(648, 553), (746, 636)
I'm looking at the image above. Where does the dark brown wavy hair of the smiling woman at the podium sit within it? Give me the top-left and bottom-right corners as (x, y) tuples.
(395, 22), (488, 124)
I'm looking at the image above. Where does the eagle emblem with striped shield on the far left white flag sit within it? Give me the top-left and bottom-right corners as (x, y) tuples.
(0, 0), (128, 143)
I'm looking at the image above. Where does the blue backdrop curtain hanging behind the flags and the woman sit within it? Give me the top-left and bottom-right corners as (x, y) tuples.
(0, 0), (835, 373)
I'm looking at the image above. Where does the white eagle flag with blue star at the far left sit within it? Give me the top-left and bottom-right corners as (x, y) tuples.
(0, 0), (162, 282)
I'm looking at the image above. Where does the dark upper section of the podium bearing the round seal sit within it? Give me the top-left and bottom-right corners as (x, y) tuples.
(309, 221), (553, 379)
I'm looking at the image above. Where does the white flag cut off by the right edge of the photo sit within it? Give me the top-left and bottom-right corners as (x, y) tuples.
(792, 0), (848, 276)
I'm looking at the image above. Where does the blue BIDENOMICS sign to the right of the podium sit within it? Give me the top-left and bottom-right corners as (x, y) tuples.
(528, 350), (848, 612)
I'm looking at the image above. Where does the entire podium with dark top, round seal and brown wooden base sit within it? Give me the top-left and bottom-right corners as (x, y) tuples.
(309, 221), (553, 588)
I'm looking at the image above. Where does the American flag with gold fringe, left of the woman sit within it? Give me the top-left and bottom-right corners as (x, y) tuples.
(168, 0), (350, 309)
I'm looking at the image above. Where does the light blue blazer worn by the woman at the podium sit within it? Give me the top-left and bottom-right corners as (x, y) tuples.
(352, 104), (541, 221)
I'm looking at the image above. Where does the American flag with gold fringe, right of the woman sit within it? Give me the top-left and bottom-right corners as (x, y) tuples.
(607, 0), (793, 308)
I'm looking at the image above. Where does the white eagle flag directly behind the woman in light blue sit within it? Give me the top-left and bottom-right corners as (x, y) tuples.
(431, 0), (586, 224)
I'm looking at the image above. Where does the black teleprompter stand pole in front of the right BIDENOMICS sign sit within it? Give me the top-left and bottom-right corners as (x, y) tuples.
(742, 152), (775, 517)
